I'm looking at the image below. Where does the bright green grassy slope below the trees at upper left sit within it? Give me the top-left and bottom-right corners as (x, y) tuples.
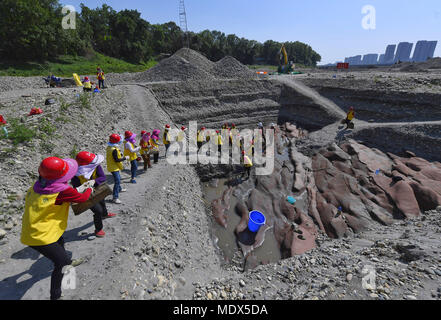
(0, 53), (157, 78)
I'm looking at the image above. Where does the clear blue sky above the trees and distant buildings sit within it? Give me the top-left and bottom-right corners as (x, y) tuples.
(60, 0), (441, 64)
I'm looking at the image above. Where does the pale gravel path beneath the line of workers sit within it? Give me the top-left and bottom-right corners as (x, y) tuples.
(0, 86), (222, 300)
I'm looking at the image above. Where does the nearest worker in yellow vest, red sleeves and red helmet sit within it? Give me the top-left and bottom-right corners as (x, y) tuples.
(20, 157), (92, 300)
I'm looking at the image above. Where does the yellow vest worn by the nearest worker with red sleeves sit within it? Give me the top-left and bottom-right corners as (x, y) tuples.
(20, 186), (70, 246)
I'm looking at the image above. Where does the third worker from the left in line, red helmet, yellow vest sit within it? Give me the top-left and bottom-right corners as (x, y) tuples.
(106, 133), (127, 204)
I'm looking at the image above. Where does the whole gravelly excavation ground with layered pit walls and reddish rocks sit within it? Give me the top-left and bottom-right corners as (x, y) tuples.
(0, 48), (441, 300)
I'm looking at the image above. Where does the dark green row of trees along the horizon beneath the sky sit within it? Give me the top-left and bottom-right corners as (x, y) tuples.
(0, 0), (321, 66)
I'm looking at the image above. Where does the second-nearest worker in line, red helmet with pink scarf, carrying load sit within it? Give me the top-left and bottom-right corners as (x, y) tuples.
(71, 151), (116, 238)
